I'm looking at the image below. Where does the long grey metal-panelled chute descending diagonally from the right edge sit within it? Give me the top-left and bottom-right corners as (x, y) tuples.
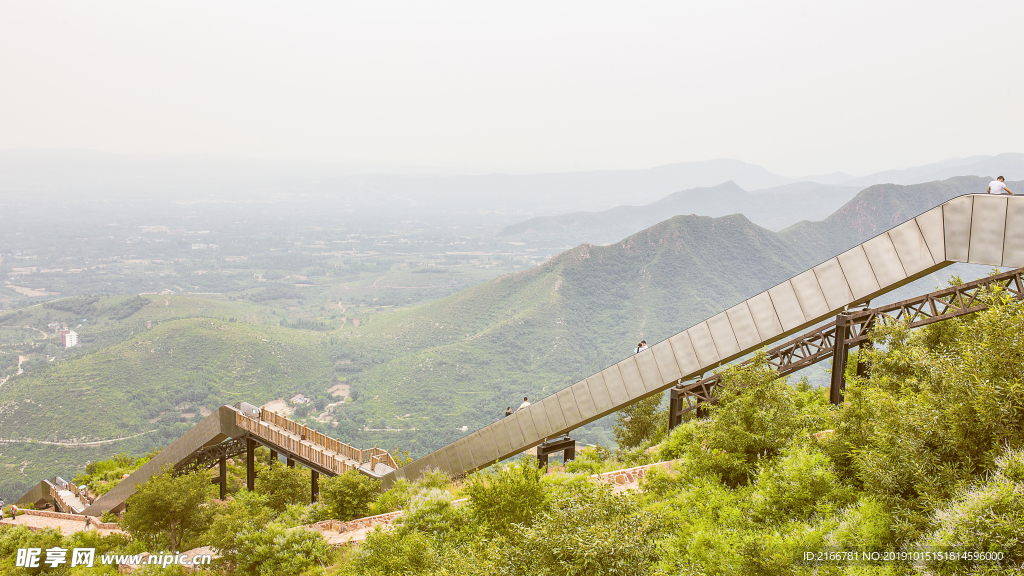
(384, 195), (1024, 485)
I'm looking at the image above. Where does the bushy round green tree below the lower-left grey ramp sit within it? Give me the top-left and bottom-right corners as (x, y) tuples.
(121, 469), (213, 553)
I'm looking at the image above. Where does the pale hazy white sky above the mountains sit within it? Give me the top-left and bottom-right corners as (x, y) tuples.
(0, 0), (1024, 176)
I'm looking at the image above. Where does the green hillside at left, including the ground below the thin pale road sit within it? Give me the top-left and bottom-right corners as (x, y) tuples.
(0, 319), (333, 498)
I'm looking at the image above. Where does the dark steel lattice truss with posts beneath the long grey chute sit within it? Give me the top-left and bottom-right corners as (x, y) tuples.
(669, 269), (1024, 428)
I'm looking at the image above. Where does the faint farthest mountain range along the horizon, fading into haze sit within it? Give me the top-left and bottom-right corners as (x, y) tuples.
(6, 150), (1024, 223)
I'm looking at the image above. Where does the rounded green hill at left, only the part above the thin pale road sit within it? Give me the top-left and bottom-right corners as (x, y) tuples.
(0, 319), (331, 442)
